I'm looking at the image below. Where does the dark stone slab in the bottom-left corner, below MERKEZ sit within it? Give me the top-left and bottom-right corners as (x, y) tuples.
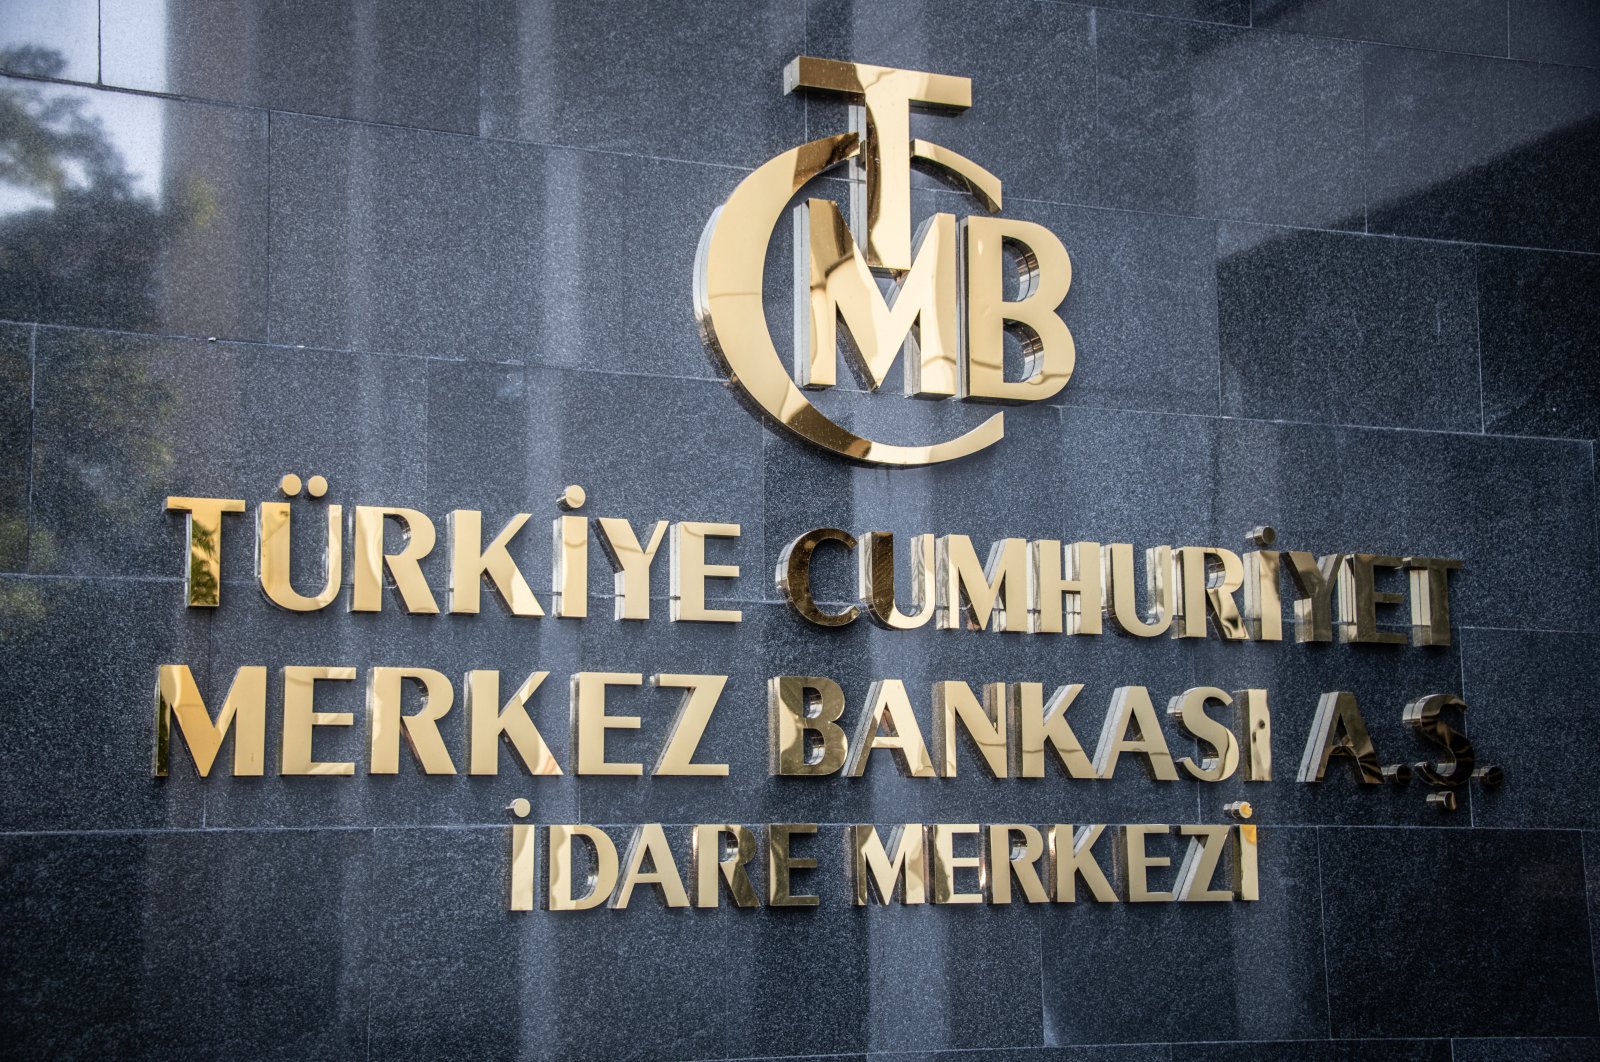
(0, 830), (373, 1059)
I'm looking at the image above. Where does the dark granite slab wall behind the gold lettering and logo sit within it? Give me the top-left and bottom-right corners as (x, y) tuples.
(0, 0), (1600, 1062)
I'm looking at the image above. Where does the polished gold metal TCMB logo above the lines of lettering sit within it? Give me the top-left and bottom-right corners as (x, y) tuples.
(694, 56), (1075, 465)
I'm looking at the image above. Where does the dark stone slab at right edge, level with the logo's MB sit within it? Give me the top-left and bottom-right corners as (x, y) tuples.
(1478, 248), (1600, 438)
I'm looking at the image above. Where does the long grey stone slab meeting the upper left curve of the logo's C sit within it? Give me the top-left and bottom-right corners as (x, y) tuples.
(270, 117), (739, 377)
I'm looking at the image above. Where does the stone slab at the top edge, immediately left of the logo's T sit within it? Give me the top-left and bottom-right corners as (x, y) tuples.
(480, 0), (806, 168)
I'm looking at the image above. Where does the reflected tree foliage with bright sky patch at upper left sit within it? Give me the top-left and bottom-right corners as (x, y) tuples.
(0, 48), (192, 329)
